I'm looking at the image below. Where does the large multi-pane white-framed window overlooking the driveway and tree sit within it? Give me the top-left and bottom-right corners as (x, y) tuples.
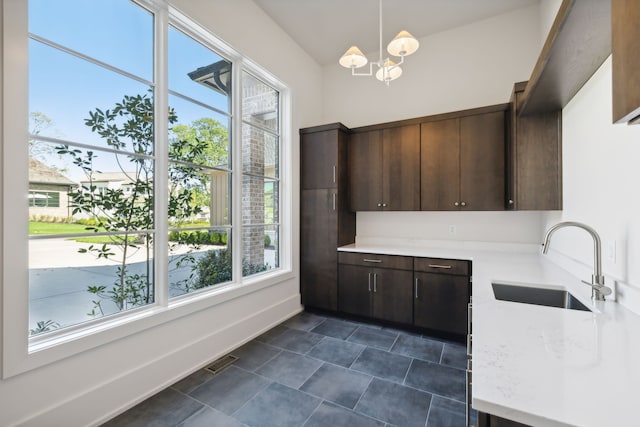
(25, 0), (281, 336)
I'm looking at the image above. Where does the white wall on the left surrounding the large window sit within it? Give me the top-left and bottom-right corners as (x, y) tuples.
(0, 0), (322, 426)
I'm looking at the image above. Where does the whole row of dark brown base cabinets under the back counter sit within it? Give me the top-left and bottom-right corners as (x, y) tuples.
(338, 252), (471, 337)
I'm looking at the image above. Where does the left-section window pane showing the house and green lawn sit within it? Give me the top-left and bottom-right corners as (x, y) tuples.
(29, 142), (154, 234)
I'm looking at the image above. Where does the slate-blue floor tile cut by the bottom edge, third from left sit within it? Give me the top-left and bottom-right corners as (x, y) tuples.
(234, 383), (321, 427)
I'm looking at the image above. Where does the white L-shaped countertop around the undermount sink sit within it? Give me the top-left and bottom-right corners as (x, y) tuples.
(339, 244), (640, 427)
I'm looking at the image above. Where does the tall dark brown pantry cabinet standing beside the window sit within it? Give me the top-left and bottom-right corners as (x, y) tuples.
(300, 124), (355, 311)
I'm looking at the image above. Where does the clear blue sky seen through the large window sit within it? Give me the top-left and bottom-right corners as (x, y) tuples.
(29, 0), (228, 179)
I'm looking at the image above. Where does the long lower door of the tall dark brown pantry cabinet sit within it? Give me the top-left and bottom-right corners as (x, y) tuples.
(300, 189), (338, 311)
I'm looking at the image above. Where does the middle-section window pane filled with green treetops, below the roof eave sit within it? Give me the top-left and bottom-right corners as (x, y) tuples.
(169, 96), (231, 169)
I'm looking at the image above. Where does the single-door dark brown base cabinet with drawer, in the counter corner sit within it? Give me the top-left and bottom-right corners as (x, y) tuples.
(413, 258), (471, 336)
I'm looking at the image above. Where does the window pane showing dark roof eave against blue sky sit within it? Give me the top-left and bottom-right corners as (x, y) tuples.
(169, 27), (231, 112)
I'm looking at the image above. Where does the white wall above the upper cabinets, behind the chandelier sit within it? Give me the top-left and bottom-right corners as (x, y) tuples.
(323, 5), (540, 127)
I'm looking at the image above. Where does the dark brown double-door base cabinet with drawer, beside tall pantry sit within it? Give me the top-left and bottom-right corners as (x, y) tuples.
(338, 252), (413, 324)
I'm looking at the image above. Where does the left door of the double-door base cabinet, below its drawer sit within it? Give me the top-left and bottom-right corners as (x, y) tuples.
(338, 264), (373, 317)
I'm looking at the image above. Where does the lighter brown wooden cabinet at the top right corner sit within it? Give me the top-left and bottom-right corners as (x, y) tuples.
(611, 0), (640, 123)
